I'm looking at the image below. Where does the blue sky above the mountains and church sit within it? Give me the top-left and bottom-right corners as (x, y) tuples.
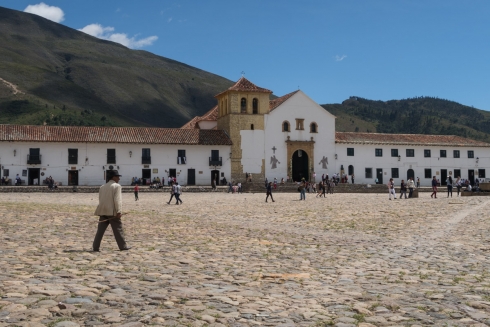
(0, 0), (490, 110)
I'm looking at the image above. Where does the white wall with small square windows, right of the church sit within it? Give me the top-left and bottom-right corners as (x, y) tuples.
(335, 144), (490, 186)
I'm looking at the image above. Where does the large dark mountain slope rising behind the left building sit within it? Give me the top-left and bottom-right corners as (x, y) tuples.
(0, 7), (233, 127)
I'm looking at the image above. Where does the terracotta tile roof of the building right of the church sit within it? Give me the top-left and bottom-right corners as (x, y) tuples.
(335, 132), (490, 147)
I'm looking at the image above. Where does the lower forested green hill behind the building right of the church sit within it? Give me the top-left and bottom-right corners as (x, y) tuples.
(322, 96), (490, 142)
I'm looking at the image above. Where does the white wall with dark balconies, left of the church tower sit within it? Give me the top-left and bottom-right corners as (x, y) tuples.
(0, 142), (231, 185)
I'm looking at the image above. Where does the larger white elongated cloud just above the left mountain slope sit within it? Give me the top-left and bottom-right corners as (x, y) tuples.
(79, 24), (158, 49)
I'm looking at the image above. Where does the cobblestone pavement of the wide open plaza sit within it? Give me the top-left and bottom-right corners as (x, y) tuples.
(0, 193), (490, 327)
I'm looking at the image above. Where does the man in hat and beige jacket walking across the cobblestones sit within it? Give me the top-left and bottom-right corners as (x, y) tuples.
(92, 170), (131, 252)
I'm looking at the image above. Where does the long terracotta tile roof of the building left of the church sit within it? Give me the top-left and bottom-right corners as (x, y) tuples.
(0, 125), (232, 145)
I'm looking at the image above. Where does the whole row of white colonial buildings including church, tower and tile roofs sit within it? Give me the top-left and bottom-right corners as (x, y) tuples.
(0, 77), (490, 186)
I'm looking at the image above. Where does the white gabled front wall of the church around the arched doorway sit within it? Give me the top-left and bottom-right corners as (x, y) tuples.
(265, 91), (335, 181)
